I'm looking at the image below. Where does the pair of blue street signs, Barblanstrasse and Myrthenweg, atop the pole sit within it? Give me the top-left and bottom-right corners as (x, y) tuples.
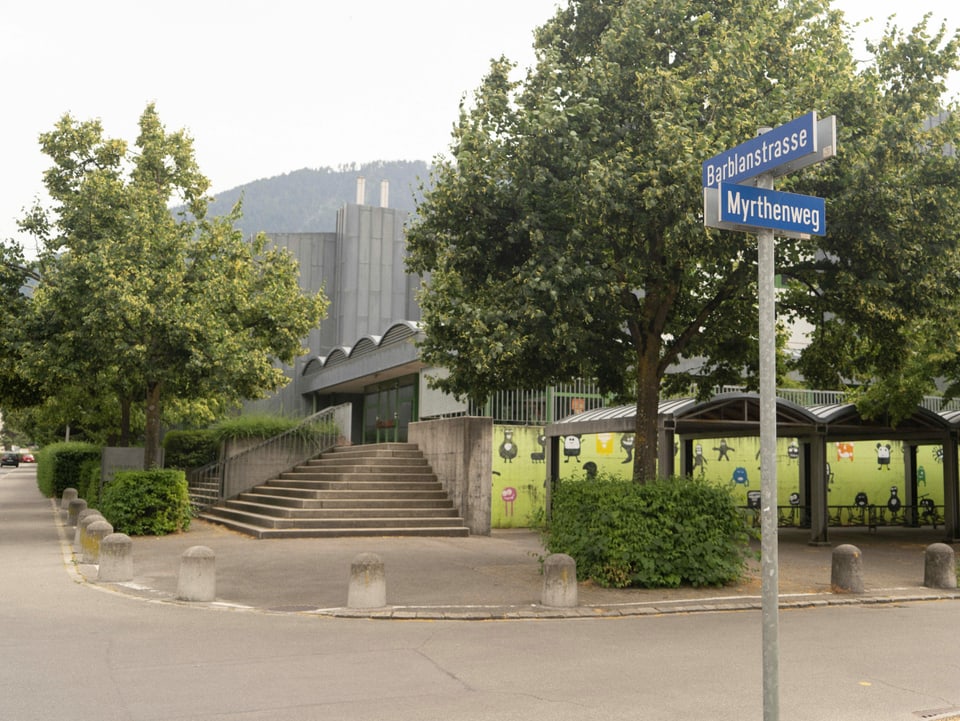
(703, 112), (837, 238)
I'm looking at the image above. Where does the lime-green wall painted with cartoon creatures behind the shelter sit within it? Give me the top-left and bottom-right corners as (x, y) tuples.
(491, 426), (943, 528)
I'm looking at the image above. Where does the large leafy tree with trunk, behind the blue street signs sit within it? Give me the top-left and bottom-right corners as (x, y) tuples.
(408, 0), (960, 480)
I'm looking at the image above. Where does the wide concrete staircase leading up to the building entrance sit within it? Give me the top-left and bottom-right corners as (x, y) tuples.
(199, 443), (469, 538)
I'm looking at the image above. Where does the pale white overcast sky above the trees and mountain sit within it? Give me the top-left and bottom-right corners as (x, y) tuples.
(0, 0), (960, 251)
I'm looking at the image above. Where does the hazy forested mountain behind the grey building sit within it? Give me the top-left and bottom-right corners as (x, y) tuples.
(207, 160), (430, 236)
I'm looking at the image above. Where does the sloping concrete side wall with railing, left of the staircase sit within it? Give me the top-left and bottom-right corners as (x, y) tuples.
(187, 403), (350, 508)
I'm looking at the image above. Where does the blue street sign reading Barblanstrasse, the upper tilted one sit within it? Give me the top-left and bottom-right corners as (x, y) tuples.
(703, 111), (820, 188)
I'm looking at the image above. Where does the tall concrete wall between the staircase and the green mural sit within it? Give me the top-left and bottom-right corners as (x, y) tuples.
(407, 416), (493, 536)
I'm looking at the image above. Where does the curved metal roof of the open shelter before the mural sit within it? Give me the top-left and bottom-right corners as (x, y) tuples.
(545, 393), (960, 442)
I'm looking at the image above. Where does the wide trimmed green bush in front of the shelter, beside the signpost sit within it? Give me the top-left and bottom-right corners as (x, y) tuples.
(545, 478), (750, 588)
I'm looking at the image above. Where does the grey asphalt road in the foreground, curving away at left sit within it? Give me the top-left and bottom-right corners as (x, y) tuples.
(0, 466), (960, 721)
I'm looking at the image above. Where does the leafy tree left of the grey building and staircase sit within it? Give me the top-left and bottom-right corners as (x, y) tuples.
(3, 105), (327, 467)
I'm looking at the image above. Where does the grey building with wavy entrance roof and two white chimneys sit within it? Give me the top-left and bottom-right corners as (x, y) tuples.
(244, 179), (603, 443)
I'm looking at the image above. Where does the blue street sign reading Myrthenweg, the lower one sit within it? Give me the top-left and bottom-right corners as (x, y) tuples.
(717, 183), (827, 237)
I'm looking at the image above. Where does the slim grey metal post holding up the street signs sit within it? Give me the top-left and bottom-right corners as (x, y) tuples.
(757, 169), (780, 721)
